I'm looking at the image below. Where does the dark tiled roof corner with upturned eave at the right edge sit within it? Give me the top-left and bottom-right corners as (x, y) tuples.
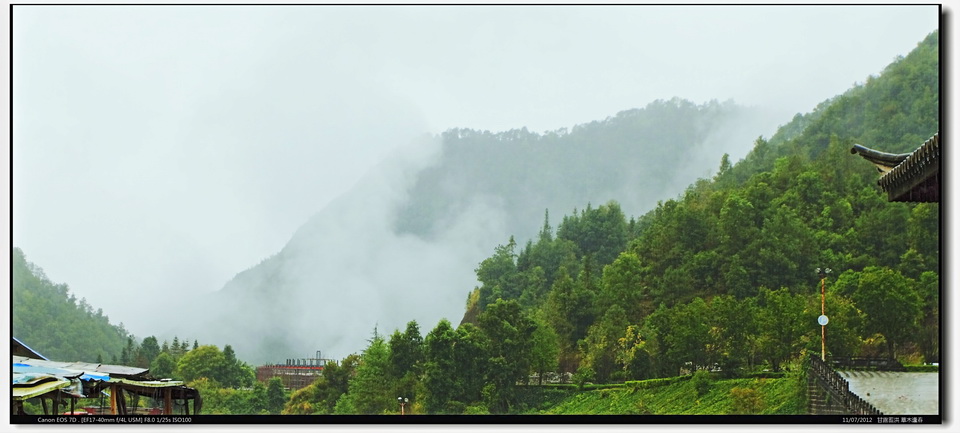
(850, 132), (940, 202)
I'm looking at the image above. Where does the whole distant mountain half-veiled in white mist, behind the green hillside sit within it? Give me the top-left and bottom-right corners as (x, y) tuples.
(184, 99), (784, 363)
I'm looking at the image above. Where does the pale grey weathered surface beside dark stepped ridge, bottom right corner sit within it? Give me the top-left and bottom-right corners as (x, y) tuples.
(838, 371), (940, 415)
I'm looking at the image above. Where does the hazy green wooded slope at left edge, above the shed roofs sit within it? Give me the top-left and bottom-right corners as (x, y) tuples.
(12, 248), (130, 362)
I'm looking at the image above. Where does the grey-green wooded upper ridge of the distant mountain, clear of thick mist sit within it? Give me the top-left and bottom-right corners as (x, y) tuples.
(397, 98), (769, 238)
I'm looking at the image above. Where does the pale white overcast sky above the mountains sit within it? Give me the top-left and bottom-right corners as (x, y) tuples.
(12, 6), (939, 343)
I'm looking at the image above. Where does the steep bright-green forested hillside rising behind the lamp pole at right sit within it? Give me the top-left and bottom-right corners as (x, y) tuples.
(467, 28), (940, 380)
